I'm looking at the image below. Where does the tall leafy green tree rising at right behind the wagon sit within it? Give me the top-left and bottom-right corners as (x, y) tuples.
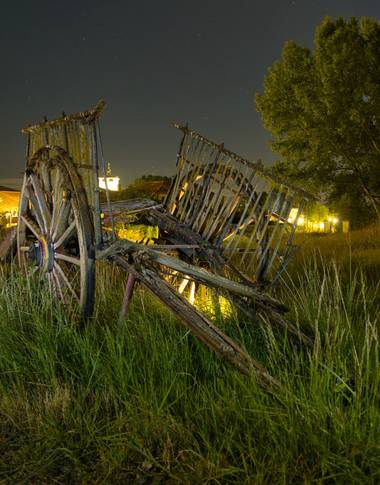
(256, 17), (380, 225)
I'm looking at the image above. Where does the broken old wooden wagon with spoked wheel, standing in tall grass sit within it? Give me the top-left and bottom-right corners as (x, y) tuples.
(17, 102), (308, 383)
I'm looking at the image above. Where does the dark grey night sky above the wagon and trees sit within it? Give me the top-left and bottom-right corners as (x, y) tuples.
(0, 0), (380, 185)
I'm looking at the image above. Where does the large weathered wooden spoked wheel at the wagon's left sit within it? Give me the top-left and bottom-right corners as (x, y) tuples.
(17, 146), (95, 317)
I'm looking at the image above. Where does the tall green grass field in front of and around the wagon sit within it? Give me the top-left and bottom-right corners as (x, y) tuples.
(0, 229), (380, 484)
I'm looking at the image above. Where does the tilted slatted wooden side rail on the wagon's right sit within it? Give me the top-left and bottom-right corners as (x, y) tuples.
(165, 124), (314, 285)
